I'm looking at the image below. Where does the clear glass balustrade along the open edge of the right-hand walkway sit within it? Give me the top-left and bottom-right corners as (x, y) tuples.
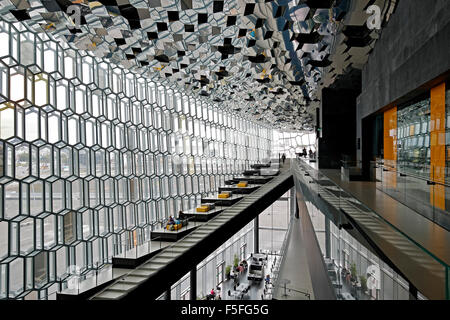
(292, 159), (450, 300)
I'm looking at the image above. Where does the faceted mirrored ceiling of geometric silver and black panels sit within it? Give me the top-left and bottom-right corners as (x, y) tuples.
(0, 0), (398, 131)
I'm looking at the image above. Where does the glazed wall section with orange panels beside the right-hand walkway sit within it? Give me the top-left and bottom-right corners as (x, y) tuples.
(377, 83), (450, 225)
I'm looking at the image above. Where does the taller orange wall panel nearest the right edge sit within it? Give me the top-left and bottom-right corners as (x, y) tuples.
(430, 83), (446, 210)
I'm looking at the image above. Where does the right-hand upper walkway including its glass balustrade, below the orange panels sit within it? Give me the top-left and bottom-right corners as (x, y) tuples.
(295, 162), (450, 299)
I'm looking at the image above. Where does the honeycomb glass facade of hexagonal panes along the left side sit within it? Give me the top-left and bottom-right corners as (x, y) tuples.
(0, 21), (272, 299)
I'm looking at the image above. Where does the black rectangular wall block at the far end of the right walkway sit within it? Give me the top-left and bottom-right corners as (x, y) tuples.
(319, 88), (359, 169)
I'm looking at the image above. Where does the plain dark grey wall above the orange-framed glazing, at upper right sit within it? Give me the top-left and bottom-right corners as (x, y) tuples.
(357, 0), (450, 157)
